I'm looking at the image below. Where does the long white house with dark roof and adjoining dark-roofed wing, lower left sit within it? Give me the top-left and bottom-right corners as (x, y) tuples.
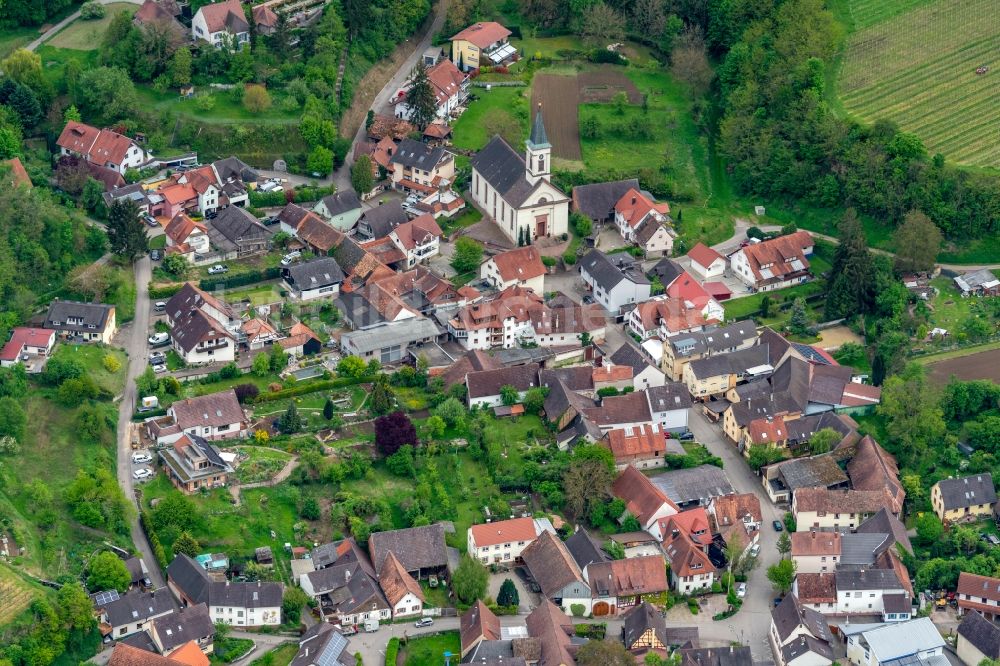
(167, 553), (284, 628)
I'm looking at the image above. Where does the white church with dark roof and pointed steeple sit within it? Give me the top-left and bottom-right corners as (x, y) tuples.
(471, 105), (570, 244)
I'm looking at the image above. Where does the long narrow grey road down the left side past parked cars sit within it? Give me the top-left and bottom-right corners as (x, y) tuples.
(118, 256), (165, 588)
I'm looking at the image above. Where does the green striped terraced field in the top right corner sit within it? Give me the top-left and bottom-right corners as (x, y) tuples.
(838, 0), (1000, 167)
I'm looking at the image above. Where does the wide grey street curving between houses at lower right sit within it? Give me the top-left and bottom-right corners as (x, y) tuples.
(690, 409), (784, 661)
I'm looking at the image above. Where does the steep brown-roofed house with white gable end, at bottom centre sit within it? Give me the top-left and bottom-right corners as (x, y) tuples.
(521, 531), (592, 614)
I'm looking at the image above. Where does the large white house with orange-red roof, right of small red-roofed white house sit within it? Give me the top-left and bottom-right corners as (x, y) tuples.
(729, 231), (813, 291)
